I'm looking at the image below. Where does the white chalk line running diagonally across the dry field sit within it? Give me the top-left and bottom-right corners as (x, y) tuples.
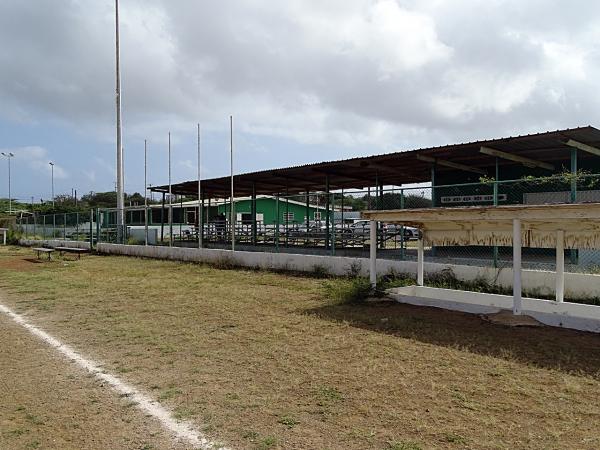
(0, 303), (225, 450)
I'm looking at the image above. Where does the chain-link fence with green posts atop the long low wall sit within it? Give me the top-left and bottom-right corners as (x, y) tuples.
(12, 174), (600, 272)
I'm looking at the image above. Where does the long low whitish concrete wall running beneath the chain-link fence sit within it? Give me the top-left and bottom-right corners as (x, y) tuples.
(94, 241), (600, 298)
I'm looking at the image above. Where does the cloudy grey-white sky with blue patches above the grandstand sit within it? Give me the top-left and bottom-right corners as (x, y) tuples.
(0, 0), (600, 201)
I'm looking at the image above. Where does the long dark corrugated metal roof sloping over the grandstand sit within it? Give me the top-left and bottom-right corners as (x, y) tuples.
(152, 126), (600, 198)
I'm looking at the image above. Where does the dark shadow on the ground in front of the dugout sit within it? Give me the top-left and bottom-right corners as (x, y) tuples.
(307, 301), (600, 379)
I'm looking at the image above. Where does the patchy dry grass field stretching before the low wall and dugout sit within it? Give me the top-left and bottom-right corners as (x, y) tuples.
(0, 247), (600, 450)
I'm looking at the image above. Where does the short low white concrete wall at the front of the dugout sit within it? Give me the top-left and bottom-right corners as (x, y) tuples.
(389, 286), (600, 333)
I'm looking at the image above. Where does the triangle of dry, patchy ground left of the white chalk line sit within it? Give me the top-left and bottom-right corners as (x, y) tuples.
(0, 298), (185, 450)
